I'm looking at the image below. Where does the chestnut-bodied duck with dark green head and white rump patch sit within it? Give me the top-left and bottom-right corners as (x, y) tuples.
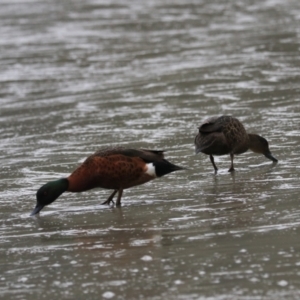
(31, 148), (183, 216)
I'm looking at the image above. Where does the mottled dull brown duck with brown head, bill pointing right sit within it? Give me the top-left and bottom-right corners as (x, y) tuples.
(195, 116), (278, 172)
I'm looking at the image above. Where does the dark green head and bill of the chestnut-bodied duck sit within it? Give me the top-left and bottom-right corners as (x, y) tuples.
(30, 178), (69, 216)
